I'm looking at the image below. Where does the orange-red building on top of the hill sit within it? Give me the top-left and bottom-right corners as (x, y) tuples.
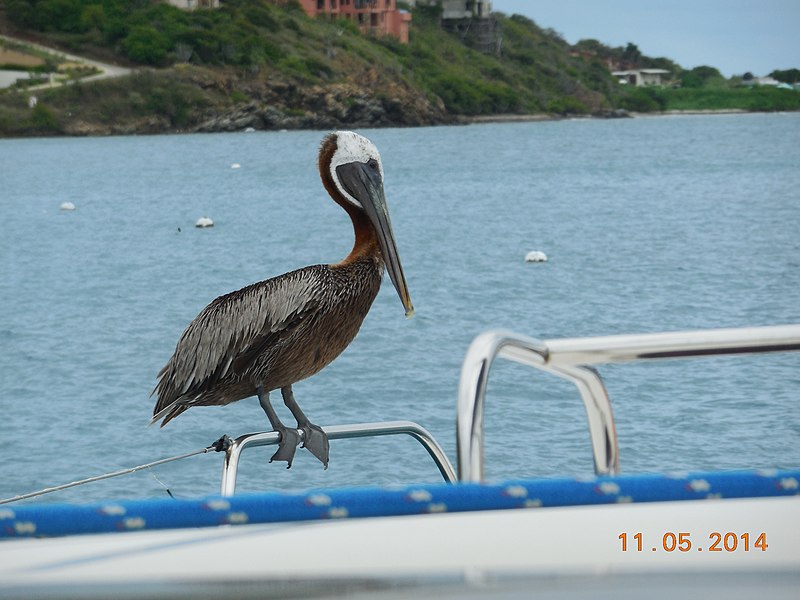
(300, 0), (411, 44)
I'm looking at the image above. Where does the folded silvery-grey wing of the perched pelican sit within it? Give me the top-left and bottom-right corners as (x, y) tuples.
(152, 267), (322, 425)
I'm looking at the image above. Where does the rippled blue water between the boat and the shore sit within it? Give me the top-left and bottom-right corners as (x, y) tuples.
(0, 114), (800, 501)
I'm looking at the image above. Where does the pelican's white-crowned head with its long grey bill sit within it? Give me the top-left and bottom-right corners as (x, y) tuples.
(320, 131), (414, 317)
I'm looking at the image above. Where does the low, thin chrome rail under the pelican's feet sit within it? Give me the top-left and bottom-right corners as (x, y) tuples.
(220, 421), (457, 496)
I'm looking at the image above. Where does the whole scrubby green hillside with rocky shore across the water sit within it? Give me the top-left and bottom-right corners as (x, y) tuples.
(0, 0), (800, 136)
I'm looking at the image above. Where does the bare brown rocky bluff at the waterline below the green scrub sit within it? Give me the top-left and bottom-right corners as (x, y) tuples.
(51, 67), (459, 136)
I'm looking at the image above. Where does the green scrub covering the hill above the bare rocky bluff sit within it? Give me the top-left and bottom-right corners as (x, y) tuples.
(0, 0), (612, 115)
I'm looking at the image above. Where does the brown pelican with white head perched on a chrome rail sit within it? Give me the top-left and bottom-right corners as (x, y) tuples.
(151, 131), (414, 468)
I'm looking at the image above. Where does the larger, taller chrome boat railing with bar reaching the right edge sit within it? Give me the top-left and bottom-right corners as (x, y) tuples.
(456, 325), (800, 482)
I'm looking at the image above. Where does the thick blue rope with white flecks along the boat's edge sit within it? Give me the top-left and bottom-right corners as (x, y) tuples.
(0, 470), (800, 538)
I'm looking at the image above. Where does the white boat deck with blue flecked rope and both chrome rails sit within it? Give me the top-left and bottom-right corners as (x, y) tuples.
(0, 325), (800, 600)
